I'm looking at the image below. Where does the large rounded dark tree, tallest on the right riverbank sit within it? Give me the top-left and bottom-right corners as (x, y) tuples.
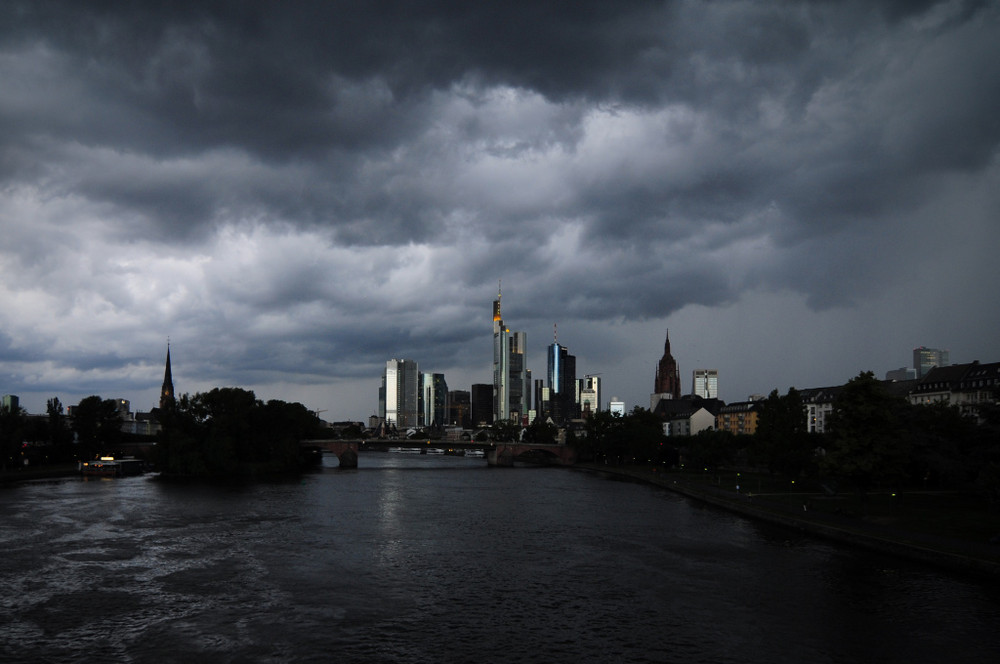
(823, 371), (912, 494)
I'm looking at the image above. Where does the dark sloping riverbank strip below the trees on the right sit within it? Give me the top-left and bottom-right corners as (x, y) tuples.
(573, 463), (1000, 579)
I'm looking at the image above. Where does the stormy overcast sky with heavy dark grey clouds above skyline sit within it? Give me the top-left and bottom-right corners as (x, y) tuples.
(0, 0), (1000, 420)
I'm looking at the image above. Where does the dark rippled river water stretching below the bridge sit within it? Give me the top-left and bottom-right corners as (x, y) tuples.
(0, 453), (1000, 664)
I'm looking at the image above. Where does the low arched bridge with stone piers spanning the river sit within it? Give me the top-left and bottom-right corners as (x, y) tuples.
(301, 439), (576, 468)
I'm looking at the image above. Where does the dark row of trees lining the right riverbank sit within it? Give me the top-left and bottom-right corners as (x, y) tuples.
(577, 372), (1000, 502)
